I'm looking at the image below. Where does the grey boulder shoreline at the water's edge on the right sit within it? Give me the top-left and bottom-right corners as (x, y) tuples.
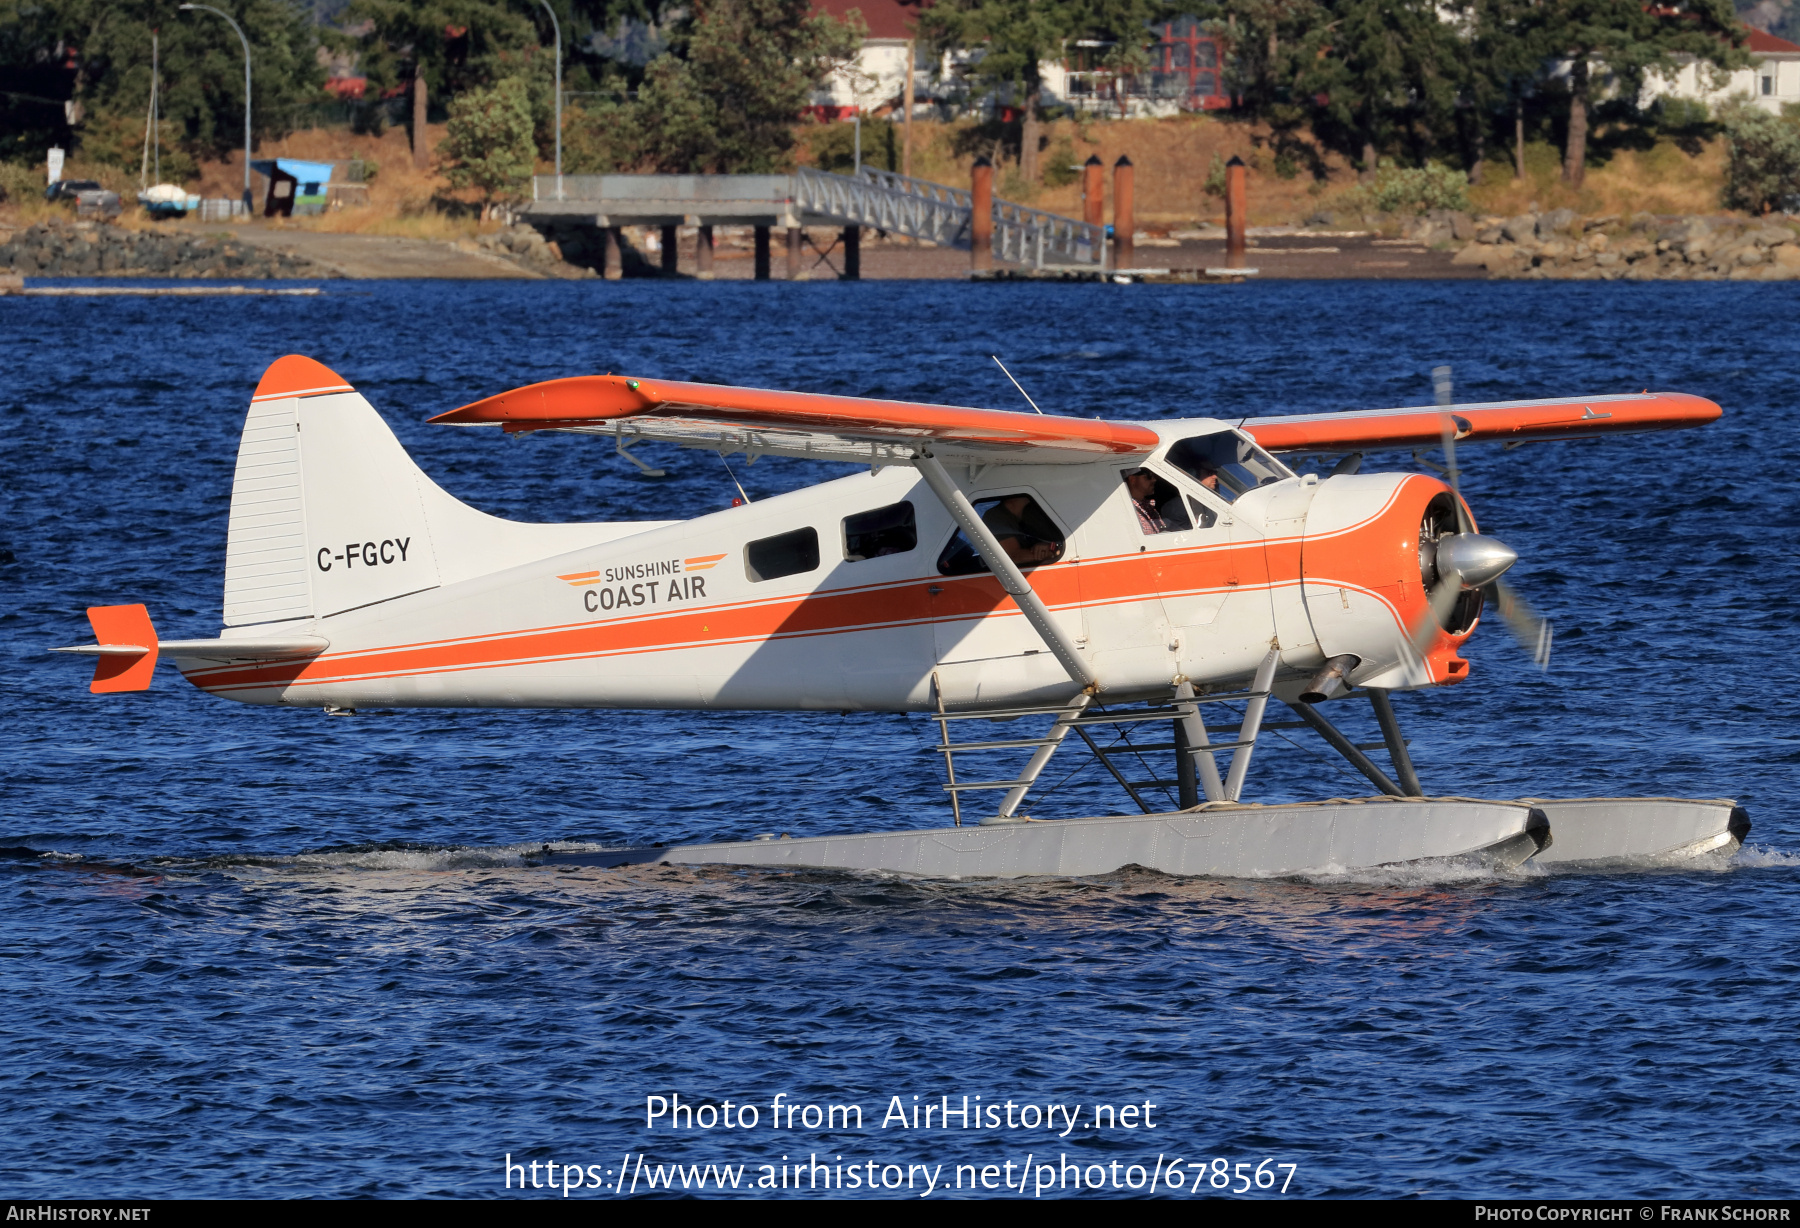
(1408, 209), (1800, 281)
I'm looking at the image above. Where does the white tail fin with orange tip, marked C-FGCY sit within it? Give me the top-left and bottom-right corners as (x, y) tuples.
(225, 355), (652, 634)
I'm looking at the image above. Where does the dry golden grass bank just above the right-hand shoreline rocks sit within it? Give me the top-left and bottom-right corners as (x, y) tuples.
(1469, 139), (1726, 216)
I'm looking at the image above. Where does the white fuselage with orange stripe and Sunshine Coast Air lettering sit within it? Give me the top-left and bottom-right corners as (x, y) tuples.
(178, 420), (1471, 711)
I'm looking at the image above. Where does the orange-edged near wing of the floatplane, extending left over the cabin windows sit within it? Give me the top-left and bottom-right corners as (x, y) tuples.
(430, 375), (1157, 465)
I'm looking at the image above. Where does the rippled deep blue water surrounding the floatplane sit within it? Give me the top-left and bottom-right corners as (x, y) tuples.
(0, 283), (1800, 1199)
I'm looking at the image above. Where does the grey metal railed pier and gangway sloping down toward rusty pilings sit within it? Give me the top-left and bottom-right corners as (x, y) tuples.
(526, 167), (1105, 268)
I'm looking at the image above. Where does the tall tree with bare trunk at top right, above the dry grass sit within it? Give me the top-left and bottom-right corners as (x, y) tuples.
(1532, 0), (1750, 187)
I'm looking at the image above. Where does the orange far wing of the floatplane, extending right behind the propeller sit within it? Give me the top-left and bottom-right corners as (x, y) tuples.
(1242, 393), (1723, 452)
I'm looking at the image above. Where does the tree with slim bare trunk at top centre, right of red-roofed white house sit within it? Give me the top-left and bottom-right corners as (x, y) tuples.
(918, 0), (1181, 184)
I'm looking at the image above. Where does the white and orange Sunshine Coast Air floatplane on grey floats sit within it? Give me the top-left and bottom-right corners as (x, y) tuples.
(61, 355), (1750, 877)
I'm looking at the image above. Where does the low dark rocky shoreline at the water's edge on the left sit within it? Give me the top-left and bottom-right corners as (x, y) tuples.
(0, 221), (327, 279)
